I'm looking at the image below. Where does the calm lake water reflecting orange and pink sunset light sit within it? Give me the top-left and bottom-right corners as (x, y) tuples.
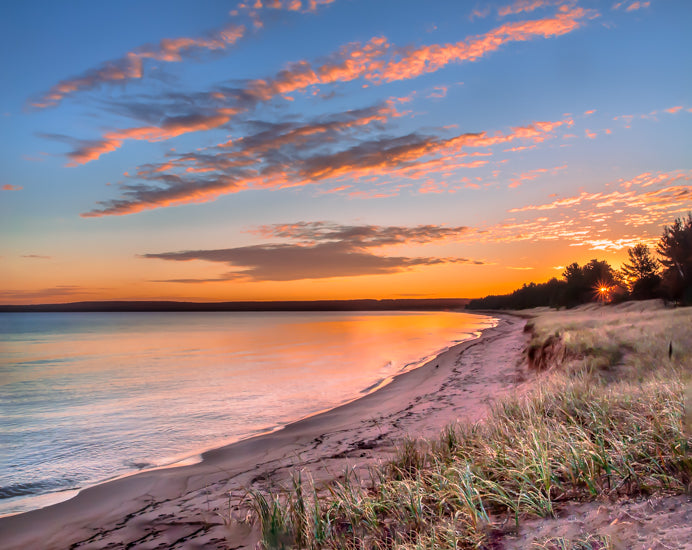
(0, 312), (493, 515)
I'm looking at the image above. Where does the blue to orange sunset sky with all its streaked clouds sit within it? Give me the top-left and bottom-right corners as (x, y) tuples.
(0, 0), (692, 304)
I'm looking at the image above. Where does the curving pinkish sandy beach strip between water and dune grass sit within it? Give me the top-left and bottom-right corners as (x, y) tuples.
(0, 315), (527, 550)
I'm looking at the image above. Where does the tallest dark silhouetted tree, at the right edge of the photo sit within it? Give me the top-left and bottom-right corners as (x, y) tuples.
(656, 213), (692, 304)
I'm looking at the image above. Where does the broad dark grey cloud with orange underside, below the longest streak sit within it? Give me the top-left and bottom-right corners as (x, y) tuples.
(82, 103), (572, 217)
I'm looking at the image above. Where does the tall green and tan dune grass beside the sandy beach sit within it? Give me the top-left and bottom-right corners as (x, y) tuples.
(250, 304), (692, 550)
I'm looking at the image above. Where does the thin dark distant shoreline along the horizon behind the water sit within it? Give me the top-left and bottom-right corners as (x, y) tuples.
(0, 298), (470, 313)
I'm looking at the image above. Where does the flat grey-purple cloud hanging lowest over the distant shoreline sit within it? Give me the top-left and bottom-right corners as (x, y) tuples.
(142, 222), (484, 283)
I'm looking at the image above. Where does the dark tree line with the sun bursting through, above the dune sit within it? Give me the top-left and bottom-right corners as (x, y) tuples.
(467, 213), (692, 309)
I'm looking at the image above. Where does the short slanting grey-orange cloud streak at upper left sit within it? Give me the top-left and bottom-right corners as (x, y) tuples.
(29, 25), (245, 109)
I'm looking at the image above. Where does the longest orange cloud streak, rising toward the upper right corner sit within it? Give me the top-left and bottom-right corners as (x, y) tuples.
(52, 6), (597, 166)
